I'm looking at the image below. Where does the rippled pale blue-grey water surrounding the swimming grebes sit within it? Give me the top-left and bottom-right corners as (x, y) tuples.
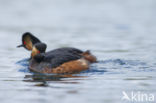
(0, 0), (156, 103)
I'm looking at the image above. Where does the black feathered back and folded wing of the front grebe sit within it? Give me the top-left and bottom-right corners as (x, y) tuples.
(34, 48), (82, 68)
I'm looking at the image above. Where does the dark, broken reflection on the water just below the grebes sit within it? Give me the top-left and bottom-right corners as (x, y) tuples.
(23, 73), (87, 87)
